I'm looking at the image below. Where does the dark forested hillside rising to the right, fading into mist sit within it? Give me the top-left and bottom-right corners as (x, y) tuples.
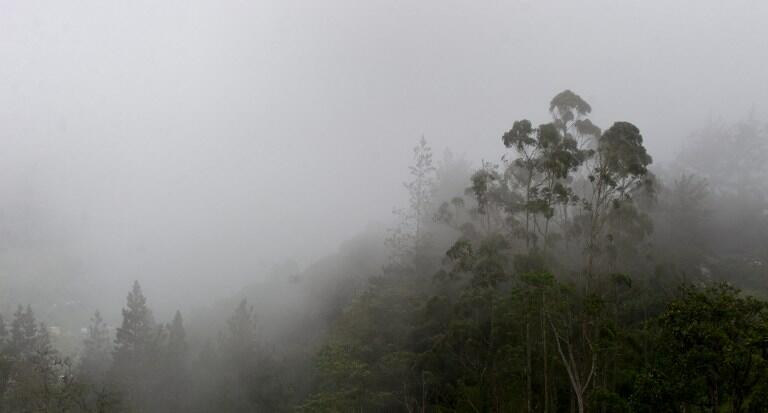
(0, 90), (768, 413)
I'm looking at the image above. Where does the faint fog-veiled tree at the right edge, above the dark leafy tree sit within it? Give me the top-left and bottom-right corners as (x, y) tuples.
(675, 114), (768, 289)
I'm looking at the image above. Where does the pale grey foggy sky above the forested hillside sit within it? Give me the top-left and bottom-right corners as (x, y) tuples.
(0, 0), (768, 308)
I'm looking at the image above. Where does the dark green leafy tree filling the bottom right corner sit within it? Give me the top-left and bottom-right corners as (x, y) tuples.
(633, 283), (768, 413)
